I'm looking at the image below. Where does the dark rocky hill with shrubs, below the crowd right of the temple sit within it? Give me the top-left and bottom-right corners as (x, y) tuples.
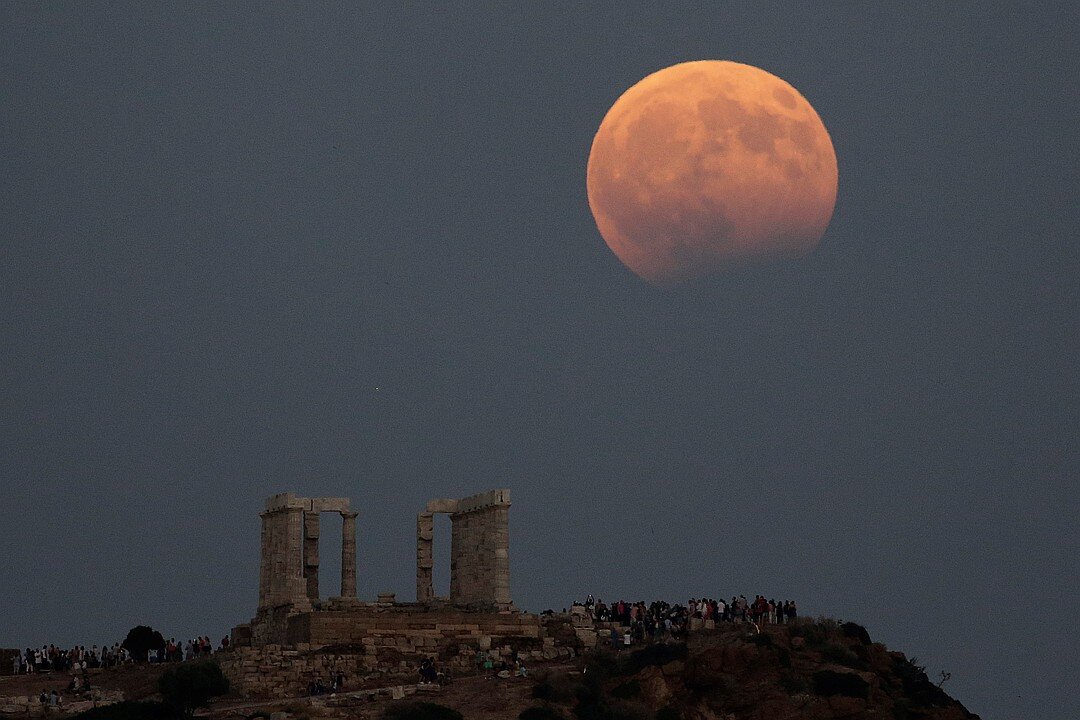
(538, 621), (977, 720)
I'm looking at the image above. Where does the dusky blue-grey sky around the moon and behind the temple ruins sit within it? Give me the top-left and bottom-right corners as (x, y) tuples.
(0, 2), (1080, 719)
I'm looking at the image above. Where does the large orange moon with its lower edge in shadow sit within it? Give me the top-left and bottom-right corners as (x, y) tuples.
(588, 60), (837, 286)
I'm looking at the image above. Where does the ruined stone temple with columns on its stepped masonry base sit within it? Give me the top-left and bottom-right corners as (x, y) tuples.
(218, 490), (595, 696)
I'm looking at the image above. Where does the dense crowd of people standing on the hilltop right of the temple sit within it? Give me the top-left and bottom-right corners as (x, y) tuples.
(573, 595), (798, 646)
